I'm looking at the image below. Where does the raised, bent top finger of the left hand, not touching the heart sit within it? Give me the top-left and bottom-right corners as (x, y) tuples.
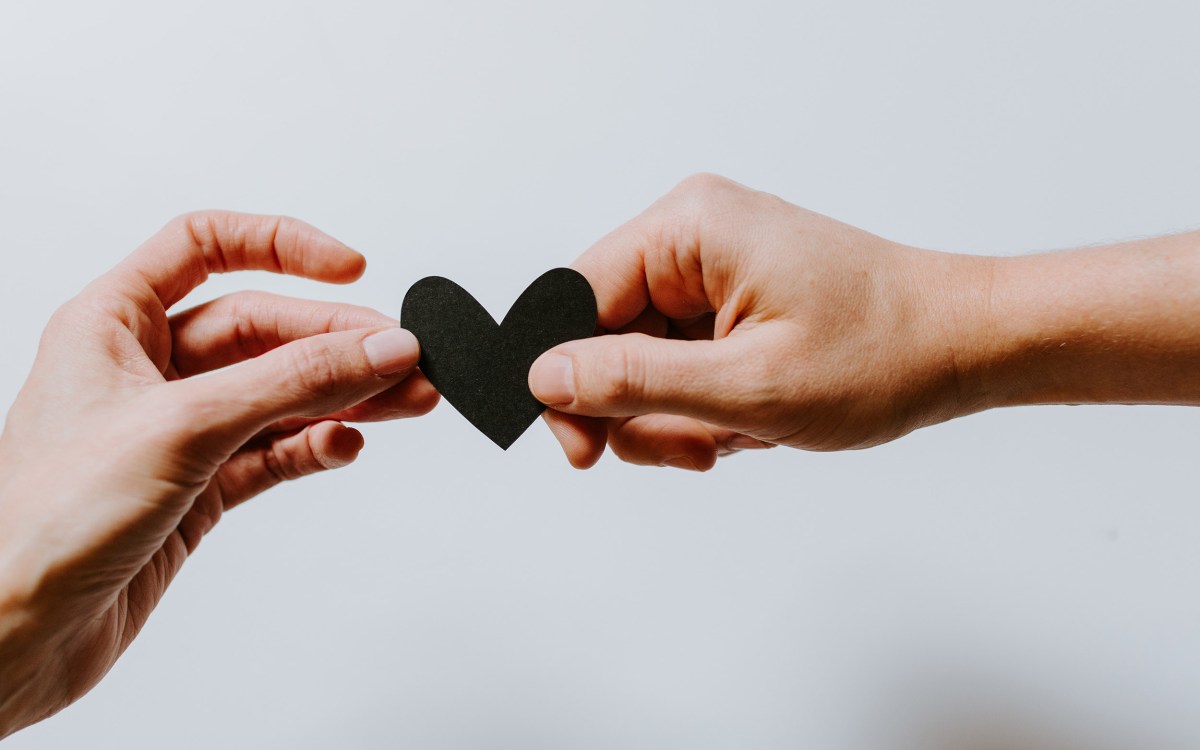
(114, 211), (366, 308)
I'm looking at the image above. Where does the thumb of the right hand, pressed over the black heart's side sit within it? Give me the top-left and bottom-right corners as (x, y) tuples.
(529, 334), (745, 424)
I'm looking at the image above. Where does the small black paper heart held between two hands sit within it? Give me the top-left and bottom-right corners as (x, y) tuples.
(400, 269), (596, 450)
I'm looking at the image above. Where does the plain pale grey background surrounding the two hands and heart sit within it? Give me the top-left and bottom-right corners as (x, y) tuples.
(0, 0), (1200, 750)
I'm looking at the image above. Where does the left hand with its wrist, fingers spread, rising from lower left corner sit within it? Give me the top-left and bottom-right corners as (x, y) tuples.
(0, 212), (438, 737)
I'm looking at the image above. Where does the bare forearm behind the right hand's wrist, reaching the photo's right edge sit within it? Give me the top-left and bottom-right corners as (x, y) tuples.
(962, 233), (1200, 408)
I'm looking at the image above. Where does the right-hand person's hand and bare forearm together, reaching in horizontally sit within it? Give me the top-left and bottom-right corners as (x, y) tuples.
(529, 175), (1200, 470)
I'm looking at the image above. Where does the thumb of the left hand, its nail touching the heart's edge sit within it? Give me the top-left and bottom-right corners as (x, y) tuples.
(180, 328), (420, 444)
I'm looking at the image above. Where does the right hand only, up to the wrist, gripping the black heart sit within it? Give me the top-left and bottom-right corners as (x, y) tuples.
(529, 175), (980, 470)
